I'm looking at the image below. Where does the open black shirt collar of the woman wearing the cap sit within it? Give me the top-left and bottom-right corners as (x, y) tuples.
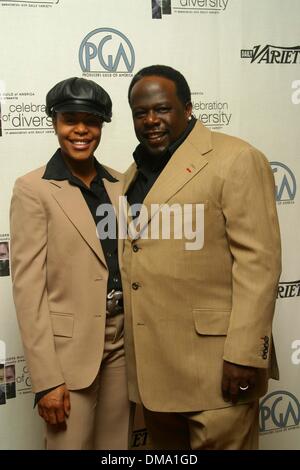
(42, 148), (118, 187)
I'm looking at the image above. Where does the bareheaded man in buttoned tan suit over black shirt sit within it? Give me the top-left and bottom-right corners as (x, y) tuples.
(123, 65), (280, 449)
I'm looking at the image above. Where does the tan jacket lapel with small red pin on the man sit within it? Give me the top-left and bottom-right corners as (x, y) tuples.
(138, 122), (212, 239)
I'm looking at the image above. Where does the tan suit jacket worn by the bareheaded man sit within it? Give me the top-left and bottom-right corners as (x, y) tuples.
(123, 122), (281, 412)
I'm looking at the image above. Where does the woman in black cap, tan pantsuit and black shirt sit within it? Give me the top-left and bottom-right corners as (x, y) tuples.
(11, 77), (129, 449)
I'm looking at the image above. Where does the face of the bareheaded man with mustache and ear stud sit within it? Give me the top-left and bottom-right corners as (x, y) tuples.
(130, 76), (192, 156)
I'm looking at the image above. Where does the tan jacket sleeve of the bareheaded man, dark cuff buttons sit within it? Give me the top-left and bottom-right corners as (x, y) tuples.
(222, 146), (281, 368)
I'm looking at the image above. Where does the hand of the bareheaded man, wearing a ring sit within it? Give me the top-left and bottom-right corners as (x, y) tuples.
(222, 361), (257, 403)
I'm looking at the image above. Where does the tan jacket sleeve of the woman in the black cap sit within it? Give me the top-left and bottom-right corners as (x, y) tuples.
(10, 178), (64, 392)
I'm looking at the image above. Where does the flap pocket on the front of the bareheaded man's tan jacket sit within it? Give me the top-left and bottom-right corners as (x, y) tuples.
(193, 308), (231, 336)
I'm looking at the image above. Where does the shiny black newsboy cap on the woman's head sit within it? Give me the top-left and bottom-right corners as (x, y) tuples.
(46, 77), (112, 122)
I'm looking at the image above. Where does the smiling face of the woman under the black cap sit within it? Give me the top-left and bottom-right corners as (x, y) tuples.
(53, 113), (102, 161)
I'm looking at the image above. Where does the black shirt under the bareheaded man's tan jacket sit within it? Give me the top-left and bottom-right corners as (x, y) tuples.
(126, 117), (197, 207)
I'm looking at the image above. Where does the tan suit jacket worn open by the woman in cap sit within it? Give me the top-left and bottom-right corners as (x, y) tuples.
(11, 162), (123, 392)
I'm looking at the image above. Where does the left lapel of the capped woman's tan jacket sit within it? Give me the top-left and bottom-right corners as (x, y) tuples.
(49, 180), (106, 266)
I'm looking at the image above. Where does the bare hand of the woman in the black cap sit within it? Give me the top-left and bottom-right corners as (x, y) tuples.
(38, 385), (71, 424)
